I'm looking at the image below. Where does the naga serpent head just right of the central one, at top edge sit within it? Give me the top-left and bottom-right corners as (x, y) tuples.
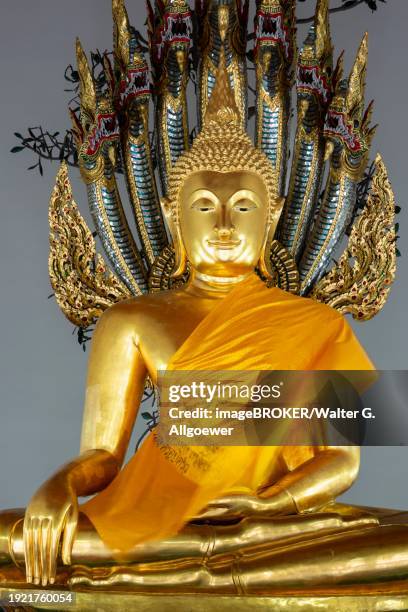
(255, 0), (296, 74)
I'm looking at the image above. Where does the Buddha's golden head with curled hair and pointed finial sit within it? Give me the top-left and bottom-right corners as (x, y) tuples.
(162, 53), (283, 277)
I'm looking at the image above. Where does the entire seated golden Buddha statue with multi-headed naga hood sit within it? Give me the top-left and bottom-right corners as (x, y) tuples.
(0, 0), (408, 609)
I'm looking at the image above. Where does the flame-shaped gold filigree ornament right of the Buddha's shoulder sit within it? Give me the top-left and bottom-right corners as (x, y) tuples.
(310, 155), (396, 321)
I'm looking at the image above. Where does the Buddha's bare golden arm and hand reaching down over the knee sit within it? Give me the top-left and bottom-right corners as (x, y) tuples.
(24, 303), (146, 585)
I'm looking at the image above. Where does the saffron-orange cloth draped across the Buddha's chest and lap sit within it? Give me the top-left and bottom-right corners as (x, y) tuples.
(80, 275), (373, 550)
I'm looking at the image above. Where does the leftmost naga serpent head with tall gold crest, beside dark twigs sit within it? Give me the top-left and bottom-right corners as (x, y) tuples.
(71, 40), (119, 172)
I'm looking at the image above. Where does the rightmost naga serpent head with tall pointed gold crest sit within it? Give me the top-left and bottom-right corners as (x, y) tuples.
(324, 34), (376, 175)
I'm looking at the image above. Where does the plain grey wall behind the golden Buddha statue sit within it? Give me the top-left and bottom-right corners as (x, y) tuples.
(0, 0), (408, 508)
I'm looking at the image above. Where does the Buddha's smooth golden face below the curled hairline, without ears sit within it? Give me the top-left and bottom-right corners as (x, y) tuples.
(179, 171), (269, 277)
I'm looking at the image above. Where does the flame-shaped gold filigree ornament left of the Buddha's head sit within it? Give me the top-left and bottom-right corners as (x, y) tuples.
(48, 162), (131, 327)
